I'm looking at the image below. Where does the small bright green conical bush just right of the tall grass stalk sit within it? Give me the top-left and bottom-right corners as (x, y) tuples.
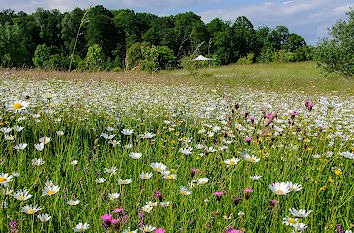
(78, 44), (106, 72)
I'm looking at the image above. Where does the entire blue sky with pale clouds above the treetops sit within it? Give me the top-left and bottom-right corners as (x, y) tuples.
(0, 0), (354, 45)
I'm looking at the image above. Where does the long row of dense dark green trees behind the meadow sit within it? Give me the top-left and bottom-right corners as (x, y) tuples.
(0, 5), (314, 71)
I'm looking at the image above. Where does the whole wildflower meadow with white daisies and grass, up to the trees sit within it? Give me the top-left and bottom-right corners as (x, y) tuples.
(0, 62), (354, 233)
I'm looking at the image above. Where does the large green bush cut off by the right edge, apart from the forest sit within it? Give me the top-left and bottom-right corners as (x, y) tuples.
(315, 9), (354, 77)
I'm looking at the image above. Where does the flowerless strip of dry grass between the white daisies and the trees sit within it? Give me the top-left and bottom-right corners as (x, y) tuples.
(2, 62), (354, 95)
